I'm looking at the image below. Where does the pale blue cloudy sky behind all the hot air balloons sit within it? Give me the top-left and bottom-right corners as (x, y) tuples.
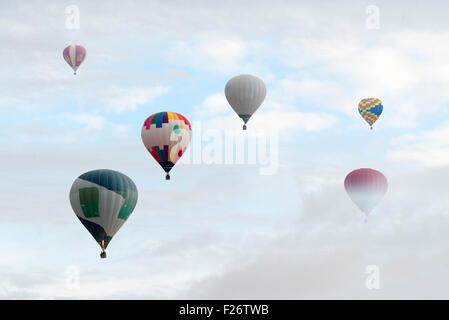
(0, 0), (449, 299)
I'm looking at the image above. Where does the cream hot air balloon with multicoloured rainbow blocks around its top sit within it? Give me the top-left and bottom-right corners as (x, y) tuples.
(142, 112), (192, 180)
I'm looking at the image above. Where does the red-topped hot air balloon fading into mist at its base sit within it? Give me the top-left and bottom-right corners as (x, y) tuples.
(345, 168), (388, 216)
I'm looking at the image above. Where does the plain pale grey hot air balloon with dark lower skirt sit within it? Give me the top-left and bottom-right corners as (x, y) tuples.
(225, 74), (267, 130)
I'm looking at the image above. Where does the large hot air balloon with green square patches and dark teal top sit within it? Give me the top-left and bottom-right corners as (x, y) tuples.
(70, 169), (137, 258)
